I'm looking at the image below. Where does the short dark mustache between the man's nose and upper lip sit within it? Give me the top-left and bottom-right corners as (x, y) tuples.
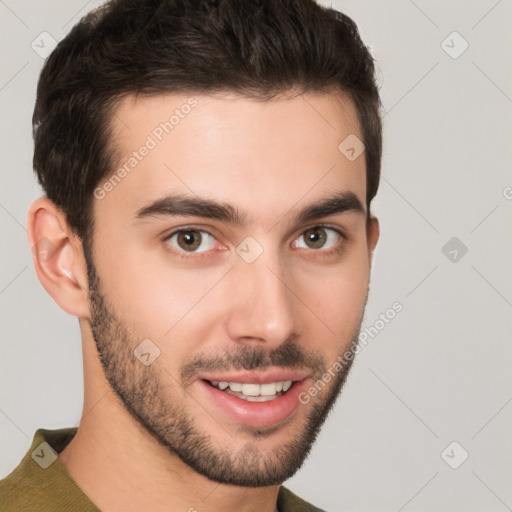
(180, 342), (326, 387)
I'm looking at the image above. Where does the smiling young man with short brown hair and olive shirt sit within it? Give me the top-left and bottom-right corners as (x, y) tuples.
(0, 0), (382, 512)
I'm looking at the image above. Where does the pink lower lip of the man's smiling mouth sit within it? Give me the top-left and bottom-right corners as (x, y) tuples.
(196, 379), (307, 428)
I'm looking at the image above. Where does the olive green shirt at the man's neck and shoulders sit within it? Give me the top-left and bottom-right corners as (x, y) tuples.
(0, 427), (323, 512)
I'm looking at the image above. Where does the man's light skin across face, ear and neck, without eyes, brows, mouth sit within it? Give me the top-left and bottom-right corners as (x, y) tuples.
(28, 93), (379, 512)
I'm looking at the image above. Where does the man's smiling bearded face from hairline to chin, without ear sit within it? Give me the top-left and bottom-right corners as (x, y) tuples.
(84, 90), (376, 486)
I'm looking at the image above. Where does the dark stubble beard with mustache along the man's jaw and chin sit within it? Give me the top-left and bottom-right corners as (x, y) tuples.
(84, 251), (364, 487)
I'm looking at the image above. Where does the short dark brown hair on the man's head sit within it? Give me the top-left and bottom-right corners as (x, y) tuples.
(33, 0), (382, 248)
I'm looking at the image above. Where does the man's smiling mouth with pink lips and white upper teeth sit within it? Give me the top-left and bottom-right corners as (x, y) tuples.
(196, 370), (309, 428)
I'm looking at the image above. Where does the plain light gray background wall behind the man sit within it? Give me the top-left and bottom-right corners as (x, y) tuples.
(0, 0), (512, 512)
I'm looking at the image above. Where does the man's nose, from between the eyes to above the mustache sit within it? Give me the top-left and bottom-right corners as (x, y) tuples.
(226, 245), (301, 350)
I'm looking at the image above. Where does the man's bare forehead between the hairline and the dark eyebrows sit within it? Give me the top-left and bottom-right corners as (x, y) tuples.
(96, 93), (366, 228)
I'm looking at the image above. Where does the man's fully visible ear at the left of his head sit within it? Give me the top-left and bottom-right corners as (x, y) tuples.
(27, 197), (89, 318)
